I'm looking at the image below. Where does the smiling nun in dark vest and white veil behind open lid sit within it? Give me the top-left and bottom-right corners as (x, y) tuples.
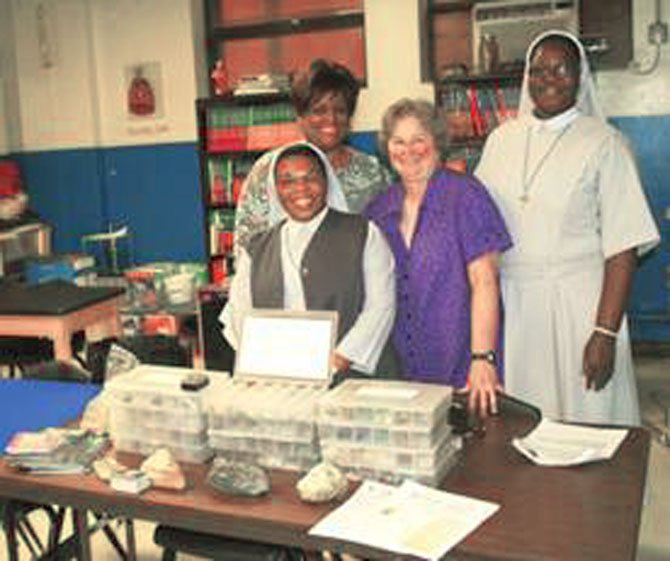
(219, 142), (396, 377)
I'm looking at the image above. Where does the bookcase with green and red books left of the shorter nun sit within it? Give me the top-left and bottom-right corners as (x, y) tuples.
(196, 94), (302, 286)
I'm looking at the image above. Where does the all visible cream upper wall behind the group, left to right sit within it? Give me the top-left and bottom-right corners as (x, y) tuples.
(0, 0), (670, 153)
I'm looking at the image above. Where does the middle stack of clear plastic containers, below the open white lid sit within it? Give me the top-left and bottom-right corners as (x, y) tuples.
(208, 377), (327, 471)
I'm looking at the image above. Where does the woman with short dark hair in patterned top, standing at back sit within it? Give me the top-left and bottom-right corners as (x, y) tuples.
(235, 59), (390, 255)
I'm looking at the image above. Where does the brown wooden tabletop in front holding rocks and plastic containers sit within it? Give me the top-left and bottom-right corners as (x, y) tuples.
(0, 402), (649, 561)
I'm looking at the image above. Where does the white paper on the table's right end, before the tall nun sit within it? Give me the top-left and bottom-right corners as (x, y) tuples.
(512, 419), (628, 466)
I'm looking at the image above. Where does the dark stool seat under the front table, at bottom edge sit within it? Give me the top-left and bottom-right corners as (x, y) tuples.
(154, 525), (302, 561)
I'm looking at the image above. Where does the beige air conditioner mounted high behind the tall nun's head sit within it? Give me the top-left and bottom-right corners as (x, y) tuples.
(472, 0), (579, 68)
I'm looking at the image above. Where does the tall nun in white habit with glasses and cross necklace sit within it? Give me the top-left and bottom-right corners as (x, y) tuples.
(475, 31), (659, 425)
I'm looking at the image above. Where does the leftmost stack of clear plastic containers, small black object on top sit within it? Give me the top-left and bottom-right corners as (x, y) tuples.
(104, 365), (231, 463)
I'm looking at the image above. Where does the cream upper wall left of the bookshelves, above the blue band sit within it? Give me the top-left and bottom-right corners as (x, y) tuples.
(0, 0), (206, 151)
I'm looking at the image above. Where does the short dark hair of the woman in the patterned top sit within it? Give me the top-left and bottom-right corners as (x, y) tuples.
(291, 58), (360, 118)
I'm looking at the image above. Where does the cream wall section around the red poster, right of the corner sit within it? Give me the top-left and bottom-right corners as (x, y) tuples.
(92, 0), (205, 146)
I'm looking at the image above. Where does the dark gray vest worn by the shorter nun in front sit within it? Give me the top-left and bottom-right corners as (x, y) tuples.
(249, 209), (368, 341)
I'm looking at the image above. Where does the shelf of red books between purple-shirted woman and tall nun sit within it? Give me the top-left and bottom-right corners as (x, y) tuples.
(435, 71), (523, 171)
